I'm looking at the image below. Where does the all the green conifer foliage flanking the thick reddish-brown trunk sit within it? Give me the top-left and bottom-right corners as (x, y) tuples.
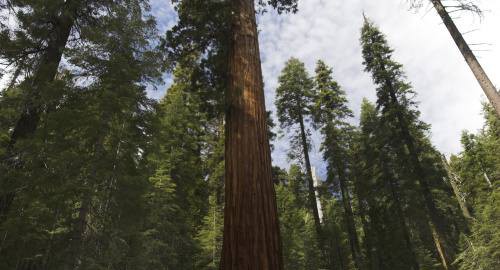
(0, 0), (500, 270)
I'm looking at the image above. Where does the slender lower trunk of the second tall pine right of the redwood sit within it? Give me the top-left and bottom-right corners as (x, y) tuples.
(337, 167), (364, 269)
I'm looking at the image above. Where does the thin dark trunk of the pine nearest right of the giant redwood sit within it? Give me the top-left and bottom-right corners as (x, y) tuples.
(299, 114), (322, 237)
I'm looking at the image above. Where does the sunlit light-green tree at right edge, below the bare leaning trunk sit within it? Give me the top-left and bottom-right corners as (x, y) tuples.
(451, 105), (500, 270)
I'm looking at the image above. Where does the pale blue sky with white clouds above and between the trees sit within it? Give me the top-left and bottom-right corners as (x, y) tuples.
(148, 0), (500, 177)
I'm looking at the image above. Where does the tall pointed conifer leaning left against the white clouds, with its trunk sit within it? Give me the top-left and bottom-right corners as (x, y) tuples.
(361, 19), (460, 268)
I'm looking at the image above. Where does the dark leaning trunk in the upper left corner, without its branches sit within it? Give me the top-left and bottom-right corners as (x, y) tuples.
(0, 0), (80, 224)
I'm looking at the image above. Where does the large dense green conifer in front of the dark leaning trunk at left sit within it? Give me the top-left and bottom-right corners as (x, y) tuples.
(0, 1), (159, 269)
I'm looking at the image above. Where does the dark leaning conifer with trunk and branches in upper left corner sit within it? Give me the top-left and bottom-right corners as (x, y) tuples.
(0, 0), (161, 228)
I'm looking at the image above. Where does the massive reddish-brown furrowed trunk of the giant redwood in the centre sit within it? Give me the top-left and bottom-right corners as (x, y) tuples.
(221, 0), (283, 270)
